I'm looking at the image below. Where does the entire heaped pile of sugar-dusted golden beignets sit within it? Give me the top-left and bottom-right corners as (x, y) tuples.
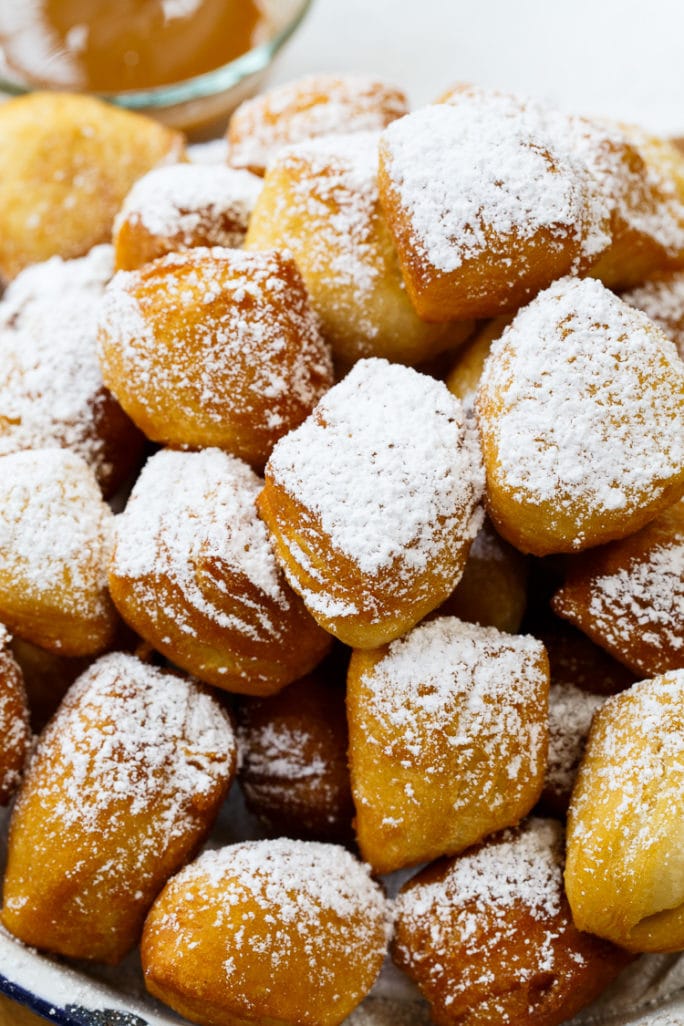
(0, 75), (684, 1026)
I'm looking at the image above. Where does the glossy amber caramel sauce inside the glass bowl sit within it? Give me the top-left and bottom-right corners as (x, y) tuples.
(0, 0), (267, 92)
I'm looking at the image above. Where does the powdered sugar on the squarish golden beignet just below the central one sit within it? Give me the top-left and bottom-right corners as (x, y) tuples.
(356, 617), (547, 808)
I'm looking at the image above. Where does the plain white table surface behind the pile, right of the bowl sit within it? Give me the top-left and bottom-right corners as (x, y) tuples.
(271, 0), (684, 135)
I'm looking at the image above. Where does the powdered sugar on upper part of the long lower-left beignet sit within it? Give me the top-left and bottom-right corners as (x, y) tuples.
(19, 653), (235, 853)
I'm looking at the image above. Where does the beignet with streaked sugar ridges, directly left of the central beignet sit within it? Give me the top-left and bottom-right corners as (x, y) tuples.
(110, 449), (330, 695)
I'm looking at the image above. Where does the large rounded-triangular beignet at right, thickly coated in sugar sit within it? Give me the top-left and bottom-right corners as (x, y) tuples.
(476, 278), (684, 555)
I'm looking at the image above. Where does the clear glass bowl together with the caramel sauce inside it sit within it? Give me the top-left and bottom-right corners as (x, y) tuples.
(0, 0), (311, 139)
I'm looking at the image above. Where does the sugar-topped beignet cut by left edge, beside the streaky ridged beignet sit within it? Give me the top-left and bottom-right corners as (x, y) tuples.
(0, 449), (118, 656)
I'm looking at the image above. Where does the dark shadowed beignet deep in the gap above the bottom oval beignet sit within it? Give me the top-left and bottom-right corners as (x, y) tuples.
(238, 653), (354, 843)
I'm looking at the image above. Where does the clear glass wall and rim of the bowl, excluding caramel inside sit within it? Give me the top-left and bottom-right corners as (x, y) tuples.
(0, 0), (313, 140)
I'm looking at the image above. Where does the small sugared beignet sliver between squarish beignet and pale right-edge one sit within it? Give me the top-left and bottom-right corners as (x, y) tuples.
(545, 683), (605, 797)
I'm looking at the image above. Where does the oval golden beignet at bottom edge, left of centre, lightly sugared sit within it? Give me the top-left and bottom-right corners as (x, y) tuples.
(142, 839), (389, 1026)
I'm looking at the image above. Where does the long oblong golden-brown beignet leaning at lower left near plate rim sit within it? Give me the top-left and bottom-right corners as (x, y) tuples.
(2, 653), (236, 963)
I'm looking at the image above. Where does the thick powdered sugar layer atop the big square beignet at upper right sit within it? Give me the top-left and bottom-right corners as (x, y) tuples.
(381, 90), (610, 273)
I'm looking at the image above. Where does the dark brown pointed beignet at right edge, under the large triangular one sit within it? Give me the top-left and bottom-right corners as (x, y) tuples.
(552, 501), (684, 677)
